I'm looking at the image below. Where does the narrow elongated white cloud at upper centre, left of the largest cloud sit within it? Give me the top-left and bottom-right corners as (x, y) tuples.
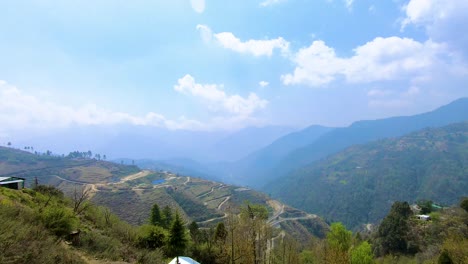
(197, 25), (289, 56)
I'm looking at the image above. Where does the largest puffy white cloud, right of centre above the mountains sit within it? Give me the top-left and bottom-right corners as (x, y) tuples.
(281, 37), (445, 86)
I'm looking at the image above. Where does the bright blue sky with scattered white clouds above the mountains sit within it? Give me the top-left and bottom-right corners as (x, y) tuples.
(0, 0), (468, 137)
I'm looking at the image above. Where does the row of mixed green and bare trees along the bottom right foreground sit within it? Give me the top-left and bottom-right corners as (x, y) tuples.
(139, 199), (468, 264)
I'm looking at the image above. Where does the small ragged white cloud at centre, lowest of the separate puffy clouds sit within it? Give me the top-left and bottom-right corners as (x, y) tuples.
(174, 74), (268, 117)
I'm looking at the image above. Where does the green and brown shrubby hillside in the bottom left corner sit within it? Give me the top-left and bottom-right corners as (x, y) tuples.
(0, 188), (164, 263)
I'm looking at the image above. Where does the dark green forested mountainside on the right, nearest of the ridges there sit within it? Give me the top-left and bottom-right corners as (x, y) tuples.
(266, 122), (468, 227)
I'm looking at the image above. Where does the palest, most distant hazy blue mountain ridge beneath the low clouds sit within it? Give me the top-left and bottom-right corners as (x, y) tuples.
(11, 125), (295, 163)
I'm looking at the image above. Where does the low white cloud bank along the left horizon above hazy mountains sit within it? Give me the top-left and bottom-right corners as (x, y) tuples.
(0, 81), (204, 133)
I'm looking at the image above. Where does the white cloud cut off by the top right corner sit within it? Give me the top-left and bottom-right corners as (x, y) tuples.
(402, 0), (468, 55)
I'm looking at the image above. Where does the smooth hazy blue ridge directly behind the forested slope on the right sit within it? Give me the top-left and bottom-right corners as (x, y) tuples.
(270, 98), (468, 186)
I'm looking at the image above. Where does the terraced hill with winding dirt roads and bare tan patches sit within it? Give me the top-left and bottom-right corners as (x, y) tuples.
(0, 147), (328, 244)
